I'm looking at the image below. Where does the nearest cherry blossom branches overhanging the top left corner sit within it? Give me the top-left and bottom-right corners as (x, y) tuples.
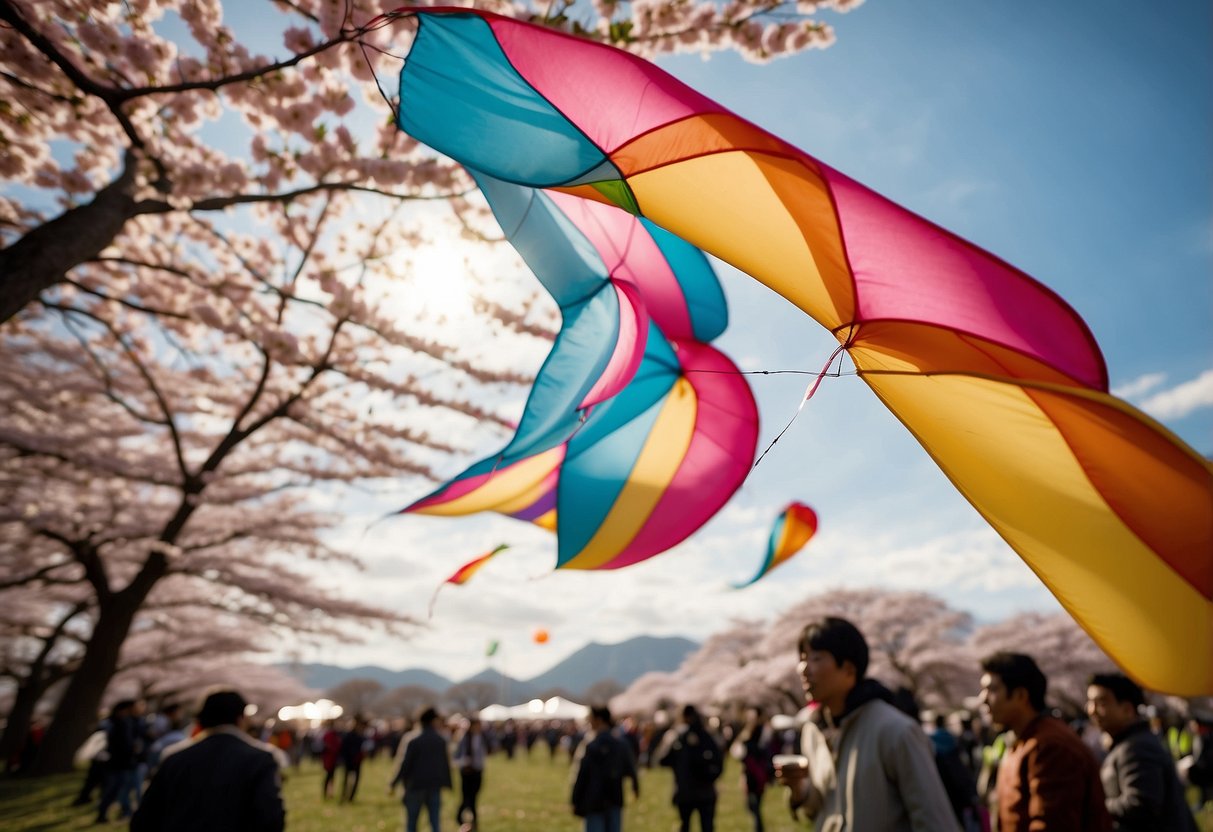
(0, 0), (873, 320)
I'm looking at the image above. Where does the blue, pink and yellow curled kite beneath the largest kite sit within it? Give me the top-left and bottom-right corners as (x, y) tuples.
(404, 172), (758, 569)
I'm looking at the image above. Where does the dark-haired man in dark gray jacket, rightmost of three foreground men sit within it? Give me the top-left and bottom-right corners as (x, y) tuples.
(1087, 673), (1196, 832)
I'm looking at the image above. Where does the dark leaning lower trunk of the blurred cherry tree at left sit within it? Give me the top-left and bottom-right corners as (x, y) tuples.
(29, 599), (140, 775)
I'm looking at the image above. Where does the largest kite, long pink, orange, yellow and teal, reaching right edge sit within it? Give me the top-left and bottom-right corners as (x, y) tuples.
(388, 7), (1213, 696)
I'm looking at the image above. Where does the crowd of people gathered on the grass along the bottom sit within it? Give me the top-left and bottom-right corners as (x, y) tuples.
(47, 617), (1213, 832)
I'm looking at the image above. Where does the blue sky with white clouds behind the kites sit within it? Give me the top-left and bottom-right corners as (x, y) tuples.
(229, 0), (1213, 678)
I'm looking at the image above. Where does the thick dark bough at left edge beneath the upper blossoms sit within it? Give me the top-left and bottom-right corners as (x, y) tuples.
(0, 150), (137, 324)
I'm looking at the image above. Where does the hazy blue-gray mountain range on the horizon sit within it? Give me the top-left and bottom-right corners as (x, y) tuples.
(279, 636), (699, 705)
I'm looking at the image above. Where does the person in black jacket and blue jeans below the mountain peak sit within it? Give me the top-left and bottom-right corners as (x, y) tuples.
(571, 705), (640, 832)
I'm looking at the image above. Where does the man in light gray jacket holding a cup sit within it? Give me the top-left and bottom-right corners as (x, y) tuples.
(775, 617), (959, 832)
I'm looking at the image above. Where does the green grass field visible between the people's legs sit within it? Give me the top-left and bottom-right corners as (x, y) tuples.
(0, 751), (1213, 832)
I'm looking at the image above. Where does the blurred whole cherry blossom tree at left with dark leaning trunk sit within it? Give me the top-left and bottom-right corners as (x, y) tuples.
(0, 193), (545, 768)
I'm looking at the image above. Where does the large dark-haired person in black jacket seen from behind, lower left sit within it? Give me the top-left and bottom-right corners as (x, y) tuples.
(131, 689), (286, 832)
